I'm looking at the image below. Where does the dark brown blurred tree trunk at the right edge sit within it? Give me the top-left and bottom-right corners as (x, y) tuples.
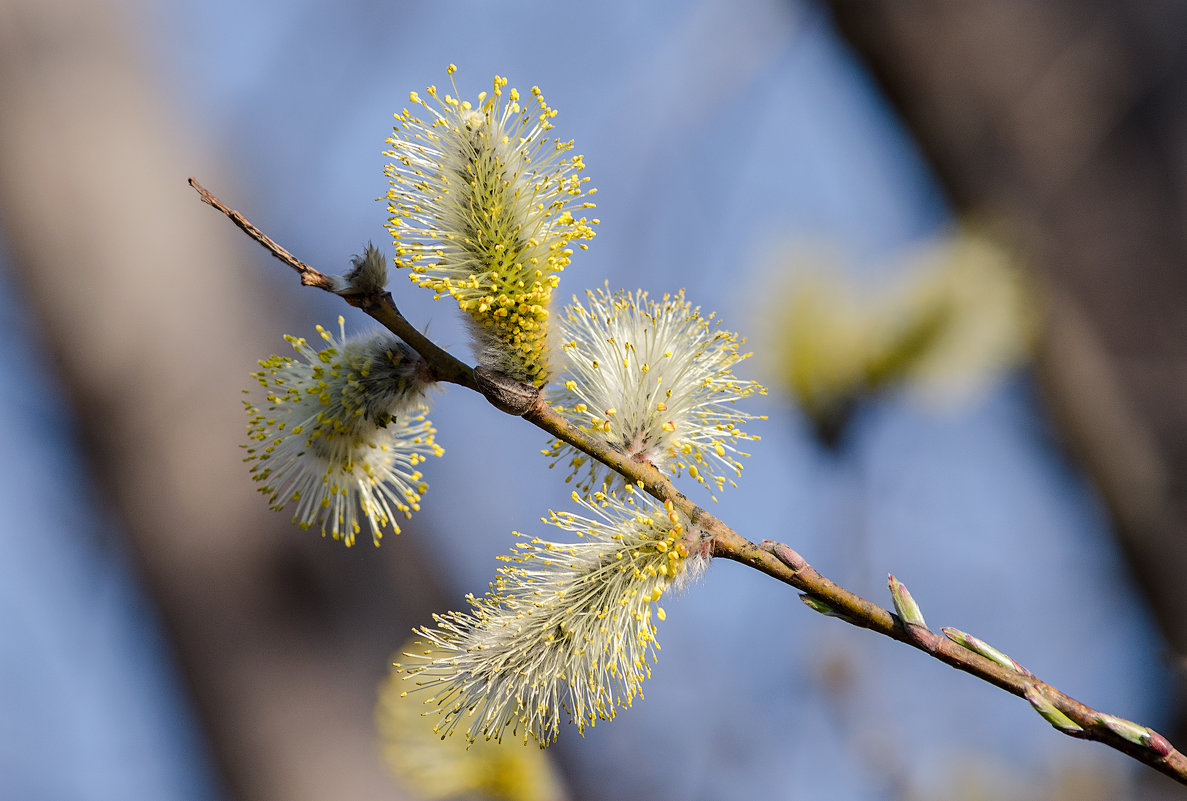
(830, 0), (1187, 797)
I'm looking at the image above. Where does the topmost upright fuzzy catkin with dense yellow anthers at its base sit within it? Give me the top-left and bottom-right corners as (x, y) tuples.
(385, 72), (597, 386)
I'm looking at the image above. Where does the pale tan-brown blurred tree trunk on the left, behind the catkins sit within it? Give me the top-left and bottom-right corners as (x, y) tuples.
(0, 0), (446, 801)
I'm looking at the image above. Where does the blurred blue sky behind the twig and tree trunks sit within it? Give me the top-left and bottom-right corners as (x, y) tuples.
(0, 0), (1164, 801)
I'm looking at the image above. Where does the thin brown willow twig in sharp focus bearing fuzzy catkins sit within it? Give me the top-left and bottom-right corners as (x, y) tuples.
(190, 178), (1187, 784)
